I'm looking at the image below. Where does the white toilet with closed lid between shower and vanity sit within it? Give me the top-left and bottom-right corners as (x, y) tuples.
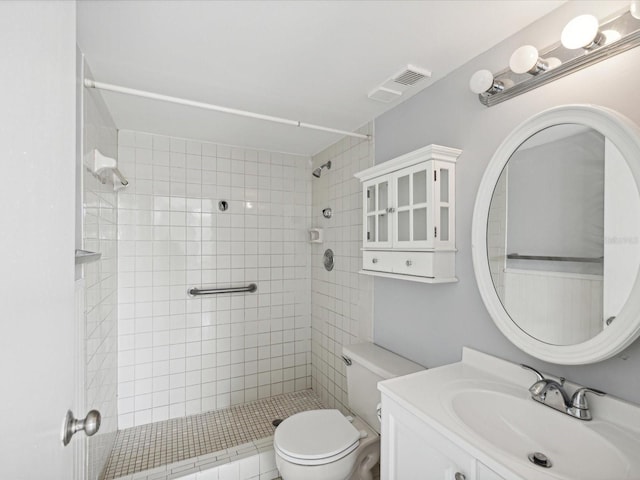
(273, 343), (424, 480)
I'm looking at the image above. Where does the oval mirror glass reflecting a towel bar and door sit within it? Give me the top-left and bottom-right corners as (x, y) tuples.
(487, 124), (640, 345)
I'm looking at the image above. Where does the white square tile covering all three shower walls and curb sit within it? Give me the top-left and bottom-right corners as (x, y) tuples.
(83, 60), (373, 480)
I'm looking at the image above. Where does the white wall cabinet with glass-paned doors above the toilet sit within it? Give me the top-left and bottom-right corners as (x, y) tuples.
(355, 145), (462, 283)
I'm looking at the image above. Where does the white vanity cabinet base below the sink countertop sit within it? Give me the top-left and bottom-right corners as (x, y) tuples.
(380, 394), (505, 480)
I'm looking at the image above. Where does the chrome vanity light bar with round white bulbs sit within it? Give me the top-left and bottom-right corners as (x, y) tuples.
(469, 4), (640, 107)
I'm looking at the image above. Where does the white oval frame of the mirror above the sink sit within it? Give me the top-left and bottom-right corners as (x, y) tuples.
(471, 105), (640, 365)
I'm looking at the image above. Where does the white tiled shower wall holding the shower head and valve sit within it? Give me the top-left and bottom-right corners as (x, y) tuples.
(311, 124), (374, 413)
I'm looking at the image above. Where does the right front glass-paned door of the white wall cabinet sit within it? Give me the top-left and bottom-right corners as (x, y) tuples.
(394, 163), (434, 248)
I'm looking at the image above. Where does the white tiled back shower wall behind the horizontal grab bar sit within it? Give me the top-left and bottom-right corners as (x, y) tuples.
(118, 131), (311, 428)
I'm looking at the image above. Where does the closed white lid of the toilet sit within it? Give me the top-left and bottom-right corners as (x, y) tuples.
(273, 410), (360, 461)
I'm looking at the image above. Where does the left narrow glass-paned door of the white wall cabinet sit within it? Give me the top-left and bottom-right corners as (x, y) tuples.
(363, 177), (391, 248)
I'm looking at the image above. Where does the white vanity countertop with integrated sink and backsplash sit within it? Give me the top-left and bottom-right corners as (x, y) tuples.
(379, 349), (640, 480)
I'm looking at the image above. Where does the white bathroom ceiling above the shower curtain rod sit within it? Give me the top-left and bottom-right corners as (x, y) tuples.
(78, 0), (564, 154)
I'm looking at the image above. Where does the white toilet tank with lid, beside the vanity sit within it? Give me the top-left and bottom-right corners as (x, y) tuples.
(342, 342), (424, 433)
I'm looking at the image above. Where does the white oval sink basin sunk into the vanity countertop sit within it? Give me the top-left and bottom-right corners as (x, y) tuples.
(448, 386), (634, 480)
